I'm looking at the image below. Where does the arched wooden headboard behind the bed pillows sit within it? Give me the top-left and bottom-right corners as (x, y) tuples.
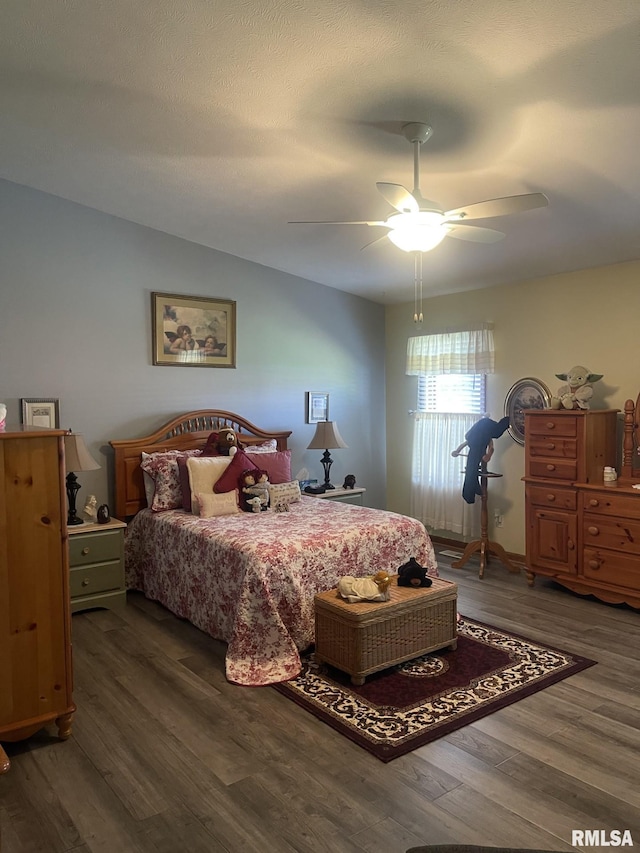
(109, 409), (291, 521)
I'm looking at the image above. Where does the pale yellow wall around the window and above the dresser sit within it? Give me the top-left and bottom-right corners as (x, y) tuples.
(386, 261), (640, 554)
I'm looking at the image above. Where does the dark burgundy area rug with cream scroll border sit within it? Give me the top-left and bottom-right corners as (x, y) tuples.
(274, 617), (596, 762)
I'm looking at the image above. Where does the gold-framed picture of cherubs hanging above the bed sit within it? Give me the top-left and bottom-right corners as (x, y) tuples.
(151, 293), (236, 367)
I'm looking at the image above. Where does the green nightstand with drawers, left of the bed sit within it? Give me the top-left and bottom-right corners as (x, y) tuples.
(67, 519), (127, 613)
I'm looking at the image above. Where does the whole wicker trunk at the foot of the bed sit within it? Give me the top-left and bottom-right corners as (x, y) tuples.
(315, 577), (458, 684)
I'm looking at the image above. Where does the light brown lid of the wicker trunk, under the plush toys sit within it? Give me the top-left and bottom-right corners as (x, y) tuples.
(315, 575), (458, 622)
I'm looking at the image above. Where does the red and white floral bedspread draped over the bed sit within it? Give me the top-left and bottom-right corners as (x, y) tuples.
(125, 497), (438, 686)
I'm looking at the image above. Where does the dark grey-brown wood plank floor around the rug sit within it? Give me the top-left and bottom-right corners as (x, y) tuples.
(0, 546), (640, 853)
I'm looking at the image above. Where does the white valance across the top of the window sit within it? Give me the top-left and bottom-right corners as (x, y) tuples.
(407, 327), (494, 376)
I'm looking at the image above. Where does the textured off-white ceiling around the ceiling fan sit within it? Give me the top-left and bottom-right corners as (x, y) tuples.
(0, 0), (640, 304)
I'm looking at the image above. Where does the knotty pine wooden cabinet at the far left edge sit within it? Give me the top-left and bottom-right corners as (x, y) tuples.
(0, 427), (75, 772)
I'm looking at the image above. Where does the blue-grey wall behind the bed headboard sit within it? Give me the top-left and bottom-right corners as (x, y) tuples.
(0, 181), (385, 507)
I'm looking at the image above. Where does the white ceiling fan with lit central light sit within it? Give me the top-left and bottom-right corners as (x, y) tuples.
(289, 122), (549, 252)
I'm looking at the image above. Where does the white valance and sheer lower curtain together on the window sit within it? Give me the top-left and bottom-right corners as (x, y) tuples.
(406, 327), (494, 538)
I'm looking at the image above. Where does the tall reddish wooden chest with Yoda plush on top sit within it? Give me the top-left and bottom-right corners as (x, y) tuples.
(524, 409), (640, 601)
